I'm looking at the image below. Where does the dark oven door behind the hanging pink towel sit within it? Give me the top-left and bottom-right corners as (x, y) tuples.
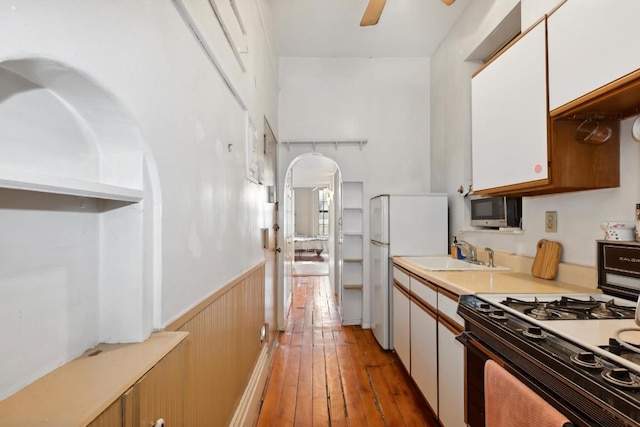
(456, 332), (593, 427)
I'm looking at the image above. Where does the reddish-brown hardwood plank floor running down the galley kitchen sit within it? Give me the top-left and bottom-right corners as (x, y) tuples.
(258, 276), (438, 427)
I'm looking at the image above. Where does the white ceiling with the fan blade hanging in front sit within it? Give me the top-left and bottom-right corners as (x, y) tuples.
(270, 0), (470, 57)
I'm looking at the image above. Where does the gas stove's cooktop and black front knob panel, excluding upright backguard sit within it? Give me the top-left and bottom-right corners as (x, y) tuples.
(458, 294), (640, 427)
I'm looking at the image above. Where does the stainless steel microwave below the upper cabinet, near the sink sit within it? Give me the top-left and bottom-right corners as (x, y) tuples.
(471, 196), (522, 228)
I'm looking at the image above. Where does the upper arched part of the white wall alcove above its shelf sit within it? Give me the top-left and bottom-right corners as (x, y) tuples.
(0, 58), (143, 196)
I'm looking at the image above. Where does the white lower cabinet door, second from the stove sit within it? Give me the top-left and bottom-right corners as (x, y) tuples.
(411, 301), (438, 415)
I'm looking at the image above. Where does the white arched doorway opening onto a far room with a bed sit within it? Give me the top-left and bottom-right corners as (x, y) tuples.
(278, 152), (342, 329)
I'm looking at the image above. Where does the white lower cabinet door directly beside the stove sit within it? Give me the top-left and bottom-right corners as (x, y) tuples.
(438, 323), (465, 427)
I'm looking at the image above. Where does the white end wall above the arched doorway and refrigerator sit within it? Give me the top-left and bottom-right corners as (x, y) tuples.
(279, 58), (430, 324)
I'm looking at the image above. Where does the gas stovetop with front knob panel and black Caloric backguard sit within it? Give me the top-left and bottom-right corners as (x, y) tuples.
(458, 241), (640, 427)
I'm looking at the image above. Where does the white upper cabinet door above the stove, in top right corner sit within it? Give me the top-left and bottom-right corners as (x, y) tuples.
(548, 0), (640, 112)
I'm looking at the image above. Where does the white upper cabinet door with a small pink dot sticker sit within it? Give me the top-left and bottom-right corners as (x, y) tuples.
(471, 21), (549, 190)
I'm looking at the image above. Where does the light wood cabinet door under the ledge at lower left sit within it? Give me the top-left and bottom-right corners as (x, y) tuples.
(134, 342), (185, 427)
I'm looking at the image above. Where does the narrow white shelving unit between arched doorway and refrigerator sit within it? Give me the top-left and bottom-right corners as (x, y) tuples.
(341, 181), (364, 325)
